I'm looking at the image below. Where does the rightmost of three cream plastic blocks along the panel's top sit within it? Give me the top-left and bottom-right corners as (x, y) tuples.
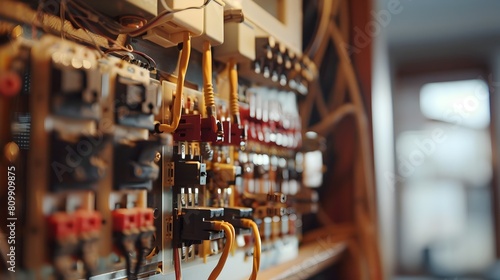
(214, 21), (255, 63)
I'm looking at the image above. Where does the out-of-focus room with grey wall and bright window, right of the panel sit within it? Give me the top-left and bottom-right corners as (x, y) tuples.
(374, 0), (500, 279)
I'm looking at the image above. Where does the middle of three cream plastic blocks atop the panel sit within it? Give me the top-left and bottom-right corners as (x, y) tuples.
(192, 0), (225, 51)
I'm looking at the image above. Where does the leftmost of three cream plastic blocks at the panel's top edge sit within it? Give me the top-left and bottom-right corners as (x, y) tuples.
(144, 0), (205, 48)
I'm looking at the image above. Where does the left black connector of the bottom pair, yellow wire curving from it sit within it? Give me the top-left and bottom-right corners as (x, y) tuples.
(173, 207), (224, 247)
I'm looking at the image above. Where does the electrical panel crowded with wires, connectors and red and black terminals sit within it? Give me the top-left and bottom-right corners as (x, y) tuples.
(0, 0), (321, 279)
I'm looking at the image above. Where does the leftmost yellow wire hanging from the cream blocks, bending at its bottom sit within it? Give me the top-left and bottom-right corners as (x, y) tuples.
(159, 32), (191, 133)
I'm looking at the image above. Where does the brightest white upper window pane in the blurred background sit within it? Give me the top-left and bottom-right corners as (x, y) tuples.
(420, 79), (490, 129)
